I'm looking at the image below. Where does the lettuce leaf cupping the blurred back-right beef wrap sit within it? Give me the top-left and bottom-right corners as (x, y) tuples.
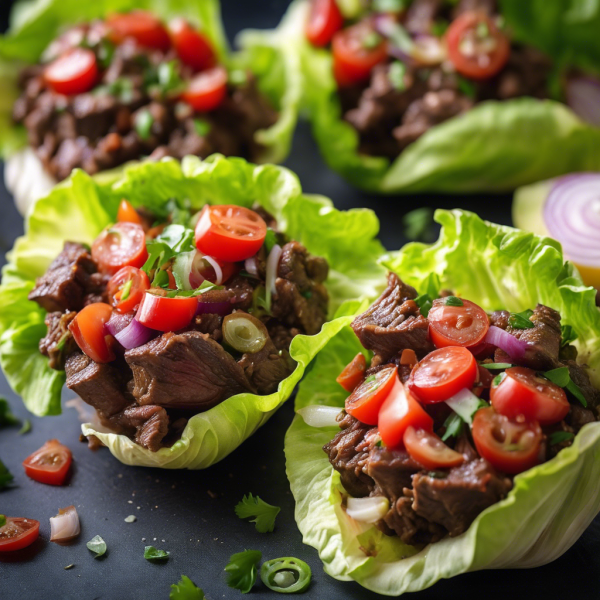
(274, 0), (600, 194)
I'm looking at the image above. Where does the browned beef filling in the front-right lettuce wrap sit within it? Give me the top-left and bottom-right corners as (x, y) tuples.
(323, 273), (600, 545)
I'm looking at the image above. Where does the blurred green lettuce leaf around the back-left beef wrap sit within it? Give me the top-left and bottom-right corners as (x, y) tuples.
(0, 0), (301, 213)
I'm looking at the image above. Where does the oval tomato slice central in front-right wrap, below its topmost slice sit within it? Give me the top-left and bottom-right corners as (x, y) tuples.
(408, 346), (478, 404)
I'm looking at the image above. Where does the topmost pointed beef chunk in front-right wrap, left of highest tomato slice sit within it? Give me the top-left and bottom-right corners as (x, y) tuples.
(352, 273), (433, 362)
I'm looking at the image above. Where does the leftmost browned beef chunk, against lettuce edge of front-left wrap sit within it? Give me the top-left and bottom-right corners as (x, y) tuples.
(29, 242), (96, 312)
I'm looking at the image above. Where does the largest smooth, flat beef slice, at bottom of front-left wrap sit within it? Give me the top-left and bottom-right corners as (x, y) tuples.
(125, 331), (256, 411)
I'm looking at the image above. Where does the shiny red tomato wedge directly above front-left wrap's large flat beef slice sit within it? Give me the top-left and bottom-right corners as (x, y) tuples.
(136, 290), (198, 332)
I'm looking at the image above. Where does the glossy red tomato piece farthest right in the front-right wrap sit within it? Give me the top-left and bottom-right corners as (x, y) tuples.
(490, 367), (570, 425)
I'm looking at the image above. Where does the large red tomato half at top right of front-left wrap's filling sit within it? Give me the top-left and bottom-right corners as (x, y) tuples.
(196, 204), (267, 262)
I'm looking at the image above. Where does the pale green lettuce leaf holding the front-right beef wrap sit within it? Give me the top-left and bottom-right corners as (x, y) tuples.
(285, 210), (600, 596)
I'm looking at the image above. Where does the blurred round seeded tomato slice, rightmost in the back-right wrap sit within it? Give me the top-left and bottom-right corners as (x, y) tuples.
(446, 11), (510, 79)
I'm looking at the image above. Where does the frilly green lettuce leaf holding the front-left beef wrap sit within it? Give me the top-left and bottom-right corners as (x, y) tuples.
(0, 155), (383, 469)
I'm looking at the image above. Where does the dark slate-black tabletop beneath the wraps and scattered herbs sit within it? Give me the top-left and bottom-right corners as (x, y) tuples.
(0, 0), (600, 600)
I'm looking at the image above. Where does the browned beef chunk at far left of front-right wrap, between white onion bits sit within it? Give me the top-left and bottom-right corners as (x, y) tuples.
(323, 414), (376, 498)
